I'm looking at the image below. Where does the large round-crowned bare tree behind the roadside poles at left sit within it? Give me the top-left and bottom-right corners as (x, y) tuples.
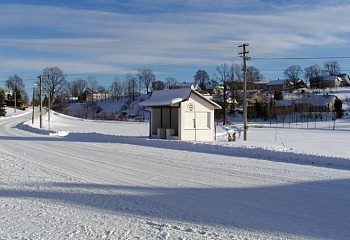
(43, 67), (67, 106)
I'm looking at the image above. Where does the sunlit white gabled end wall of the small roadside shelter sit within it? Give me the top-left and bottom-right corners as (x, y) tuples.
(179, 94), (215, 141)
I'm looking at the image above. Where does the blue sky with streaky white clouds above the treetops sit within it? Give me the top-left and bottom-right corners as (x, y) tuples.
(0, 0), (350, 94)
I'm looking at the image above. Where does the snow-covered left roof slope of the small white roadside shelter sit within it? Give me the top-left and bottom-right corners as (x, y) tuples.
(139, 88), (191, 107)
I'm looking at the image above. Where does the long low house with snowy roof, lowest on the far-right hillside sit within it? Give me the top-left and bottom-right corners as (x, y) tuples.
(296, 94), (339, 112)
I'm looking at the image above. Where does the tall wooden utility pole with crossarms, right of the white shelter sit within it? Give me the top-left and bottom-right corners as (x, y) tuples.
(238, 43), (250, 141)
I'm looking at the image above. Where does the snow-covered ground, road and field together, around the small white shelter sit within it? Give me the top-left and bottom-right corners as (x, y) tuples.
(0, 109), (350, 239)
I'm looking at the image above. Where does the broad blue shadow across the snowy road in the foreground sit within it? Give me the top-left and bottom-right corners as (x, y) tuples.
(0, 179), (350, 239)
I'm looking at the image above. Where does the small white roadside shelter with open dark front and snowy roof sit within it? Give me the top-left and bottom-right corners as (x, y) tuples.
(139, 88), (221, 141)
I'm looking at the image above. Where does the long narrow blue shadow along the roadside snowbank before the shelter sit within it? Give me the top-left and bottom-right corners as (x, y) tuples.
(0, 123), (350, 170)
